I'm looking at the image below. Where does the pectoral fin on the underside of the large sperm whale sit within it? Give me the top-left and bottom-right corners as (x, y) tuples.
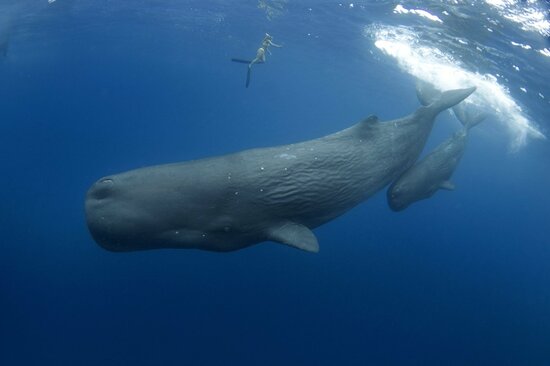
(267, 222), (319, 253)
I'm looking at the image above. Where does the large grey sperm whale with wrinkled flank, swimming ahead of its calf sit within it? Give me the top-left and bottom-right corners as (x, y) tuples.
(85, 88), (475, 252)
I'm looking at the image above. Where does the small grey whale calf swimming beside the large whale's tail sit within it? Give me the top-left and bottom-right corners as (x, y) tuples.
(387, 104), (485, 211)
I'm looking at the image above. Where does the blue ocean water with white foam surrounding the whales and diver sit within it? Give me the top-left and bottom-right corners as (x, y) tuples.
(0, 0), (550, 365)
